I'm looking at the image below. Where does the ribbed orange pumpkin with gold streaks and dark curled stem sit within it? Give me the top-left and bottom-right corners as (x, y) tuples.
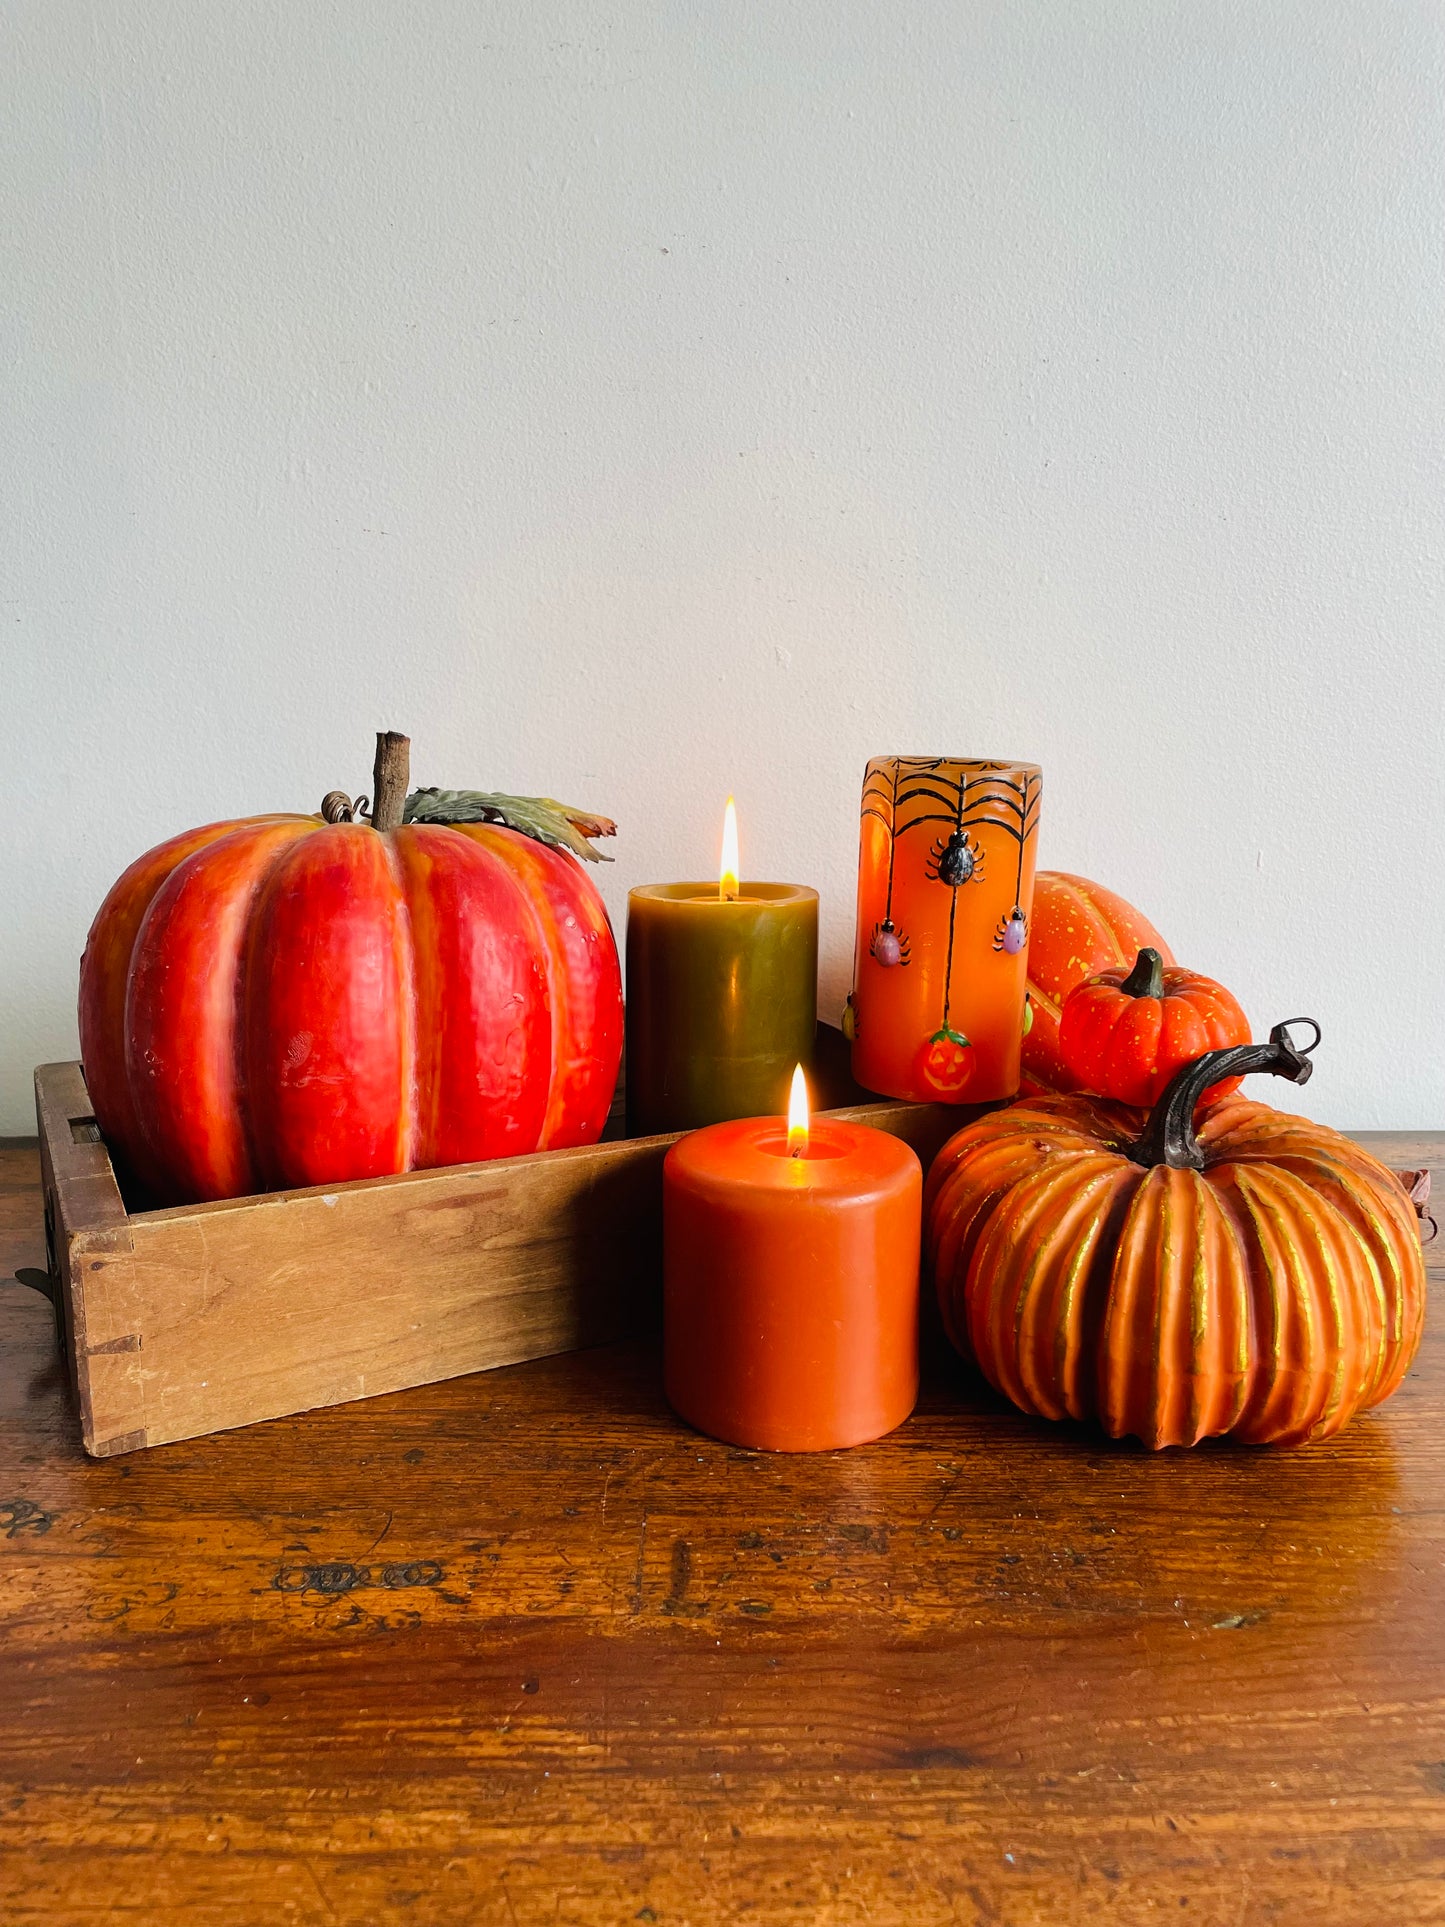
(925, 1025), (1426, 1447)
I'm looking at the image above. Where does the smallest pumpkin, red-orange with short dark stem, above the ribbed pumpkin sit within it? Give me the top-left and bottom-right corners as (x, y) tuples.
(1058, 946), (1248, 1104)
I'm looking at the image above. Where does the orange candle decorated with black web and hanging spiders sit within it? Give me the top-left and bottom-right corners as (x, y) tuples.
(844, 755), (1042, 1104)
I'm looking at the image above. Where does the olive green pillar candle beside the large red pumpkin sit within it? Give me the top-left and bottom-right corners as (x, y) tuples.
(626, 883), (817, 1137)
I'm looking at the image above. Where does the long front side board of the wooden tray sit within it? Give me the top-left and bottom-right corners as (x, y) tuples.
(100, 1145), (663, 1445)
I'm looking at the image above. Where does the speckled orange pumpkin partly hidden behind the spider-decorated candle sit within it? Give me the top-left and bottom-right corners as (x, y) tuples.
(1019, 869), (1173, 1096)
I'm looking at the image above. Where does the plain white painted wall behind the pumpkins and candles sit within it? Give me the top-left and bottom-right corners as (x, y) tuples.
(0, 0), (1445, 1133)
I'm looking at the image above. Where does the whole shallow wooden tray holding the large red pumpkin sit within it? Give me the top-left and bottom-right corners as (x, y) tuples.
(35, 1052), (971, 1457)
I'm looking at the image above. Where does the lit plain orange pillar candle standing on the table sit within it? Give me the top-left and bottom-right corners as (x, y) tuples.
(663, 1077), (923, 1451)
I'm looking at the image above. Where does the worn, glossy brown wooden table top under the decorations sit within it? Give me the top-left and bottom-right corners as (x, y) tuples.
(0, 1135), (1445, 1927)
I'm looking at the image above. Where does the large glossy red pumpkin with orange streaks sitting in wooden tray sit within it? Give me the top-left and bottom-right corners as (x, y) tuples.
(79, 736), (622, 1202)
